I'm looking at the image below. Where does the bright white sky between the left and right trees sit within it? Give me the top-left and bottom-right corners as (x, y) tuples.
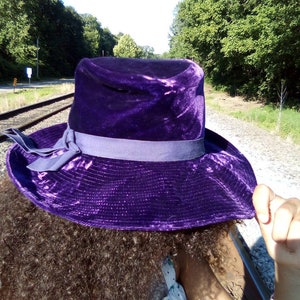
(63, 0), (180, 54)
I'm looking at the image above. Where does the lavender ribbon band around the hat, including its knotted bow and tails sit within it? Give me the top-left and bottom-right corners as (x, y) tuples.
(4, 127), (205, 172)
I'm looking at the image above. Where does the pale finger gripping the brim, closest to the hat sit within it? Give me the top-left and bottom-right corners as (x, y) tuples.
(253, 184), (275, 223)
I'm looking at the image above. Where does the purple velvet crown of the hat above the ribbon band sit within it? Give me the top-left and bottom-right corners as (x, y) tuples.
(69, 57), (205, 141)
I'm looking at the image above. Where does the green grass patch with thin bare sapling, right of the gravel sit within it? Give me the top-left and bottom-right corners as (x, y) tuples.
(231, 105), (300, 144)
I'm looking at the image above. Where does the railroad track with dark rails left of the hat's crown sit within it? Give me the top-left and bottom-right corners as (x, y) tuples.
(0, 93), (74, 142)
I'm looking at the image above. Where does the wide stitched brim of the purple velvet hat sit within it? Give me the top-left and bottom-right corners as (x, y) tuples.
(7, 124), (256, 231)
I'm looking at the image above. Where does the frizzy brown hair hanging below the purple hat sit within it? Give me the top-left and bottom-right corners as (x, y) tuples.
(0, 179), (232, 300)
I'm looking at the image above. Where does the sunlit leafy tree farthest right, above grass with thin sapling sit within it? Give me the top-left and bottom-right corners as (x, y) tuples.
(222, 0), (300, 99)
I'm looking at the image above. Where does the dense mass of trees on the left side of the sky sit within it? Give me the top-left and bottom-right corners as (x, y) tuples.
(0, 0), (117, 80)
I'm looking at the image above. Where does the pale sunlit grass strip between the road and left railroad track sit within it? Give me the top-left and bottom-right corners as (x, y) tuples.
(0, 83), (74, 113)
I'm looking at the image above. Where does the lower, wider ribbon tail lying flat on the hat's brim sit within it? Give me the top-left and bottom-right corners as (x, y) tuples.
(27, 150), (80, 172)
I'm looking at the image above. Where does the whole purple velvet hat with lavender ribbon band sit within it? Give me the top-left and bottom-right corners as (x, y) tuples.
(6, 57), (256, 230)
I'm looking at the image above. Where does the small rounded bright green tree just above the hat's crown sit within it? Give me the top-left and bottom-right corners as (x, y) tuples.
(113, 34), (143, 58)
